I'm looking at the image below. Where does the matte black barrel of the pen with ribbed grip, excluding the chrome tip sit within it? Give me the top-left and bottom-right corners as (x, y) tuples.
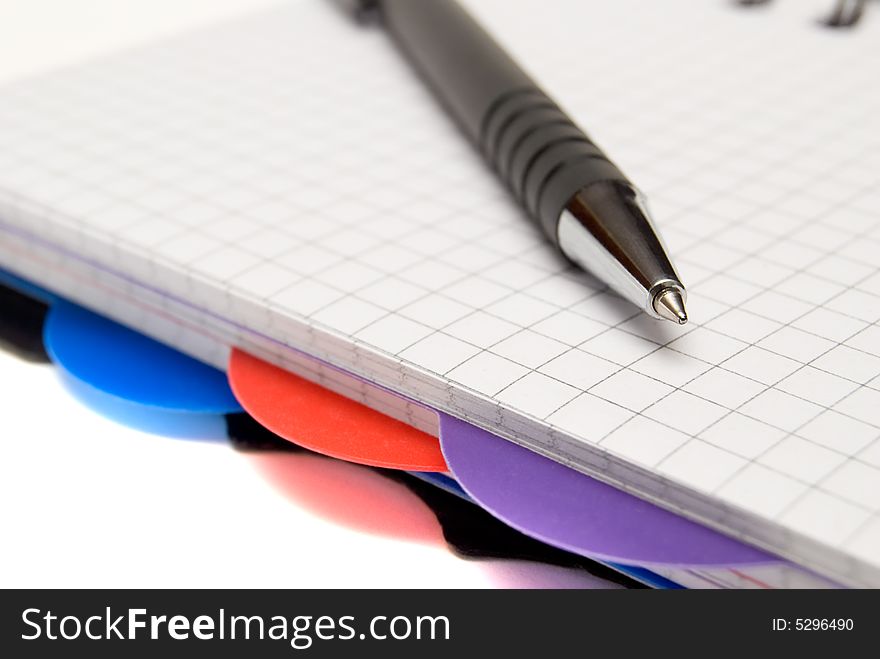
(379, 0), (629, 244)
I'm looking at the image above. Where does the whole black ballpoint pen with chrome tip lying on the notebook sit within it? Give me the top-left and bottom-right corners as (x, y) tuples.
(343, 0), (687, 324)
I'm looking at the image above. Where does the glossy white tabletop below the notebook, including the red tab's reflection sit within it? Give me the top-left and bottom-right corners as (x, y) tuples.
(0, 352), (609, 588)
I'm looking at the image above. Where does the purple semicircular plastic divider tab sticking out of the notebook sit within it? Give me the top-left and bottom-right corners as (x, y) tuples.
(440, 413), (779, 566)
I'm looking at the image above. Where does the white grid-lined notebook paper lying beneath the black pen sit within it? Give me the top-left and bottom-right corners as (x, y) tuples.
(0, 0), (880, 585)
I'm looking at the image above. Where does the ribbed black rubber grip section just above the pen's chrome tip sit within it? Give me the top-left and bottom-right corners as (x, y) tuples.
(479, 87), (627, 242)
